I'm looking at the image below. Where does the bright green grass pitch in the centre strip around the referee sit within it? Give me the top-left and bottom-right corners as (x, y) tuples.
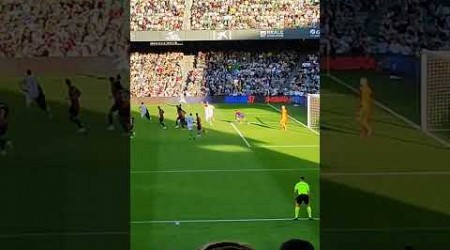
(131, 104), (320, 250)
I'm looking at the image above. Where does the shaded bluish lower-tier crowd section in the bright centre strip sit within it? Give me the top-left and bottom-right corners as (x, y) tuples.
(204, 51), (318, 96)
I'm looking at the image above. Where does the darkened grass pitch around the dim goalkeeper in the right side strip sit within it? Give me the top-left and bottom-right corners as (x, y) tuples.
(321, 71), (450, 250)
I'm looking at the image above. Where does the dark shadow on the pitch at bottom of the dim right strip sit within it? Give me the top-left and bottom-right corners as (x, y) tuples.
(320, 178), (450, 250)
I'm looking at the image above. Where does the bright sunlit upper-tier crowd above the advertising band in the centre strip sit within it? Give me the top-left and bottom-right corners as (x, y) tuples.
(131, 0), (320, 31)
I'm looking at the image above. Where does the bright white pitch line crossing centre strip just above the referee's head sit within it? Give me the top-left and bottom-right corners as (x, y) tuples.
(131, 168), (320, 174)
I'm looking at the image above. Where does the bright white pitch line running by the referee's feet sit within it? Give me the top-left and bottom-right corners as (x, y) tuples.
(130, 218), (320, 224)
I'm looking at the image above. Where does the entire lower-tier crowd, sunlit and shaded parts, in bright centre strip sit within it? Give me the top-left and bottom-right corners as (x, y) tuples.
(131, 50), (320, 97)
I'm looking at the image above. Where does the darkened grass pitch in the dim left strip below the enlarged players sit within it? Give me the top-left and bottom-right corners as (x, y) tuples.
(0, 74), (129, 250)
